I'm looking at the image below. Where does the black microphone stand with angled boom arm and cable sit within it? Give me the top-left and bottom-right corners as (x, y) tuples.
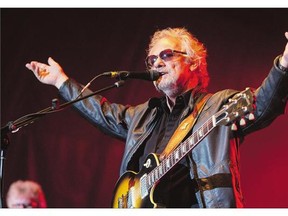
(0, 80), (124, 208)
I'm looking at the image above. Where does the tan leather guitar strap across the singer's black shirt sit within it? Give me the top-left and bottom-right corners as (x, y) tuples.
(159, 94), (212, 161)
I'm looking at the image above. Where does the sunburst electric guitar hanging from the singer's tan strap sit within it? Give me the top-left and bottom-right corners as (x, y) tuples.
(112, 88), (254, 208)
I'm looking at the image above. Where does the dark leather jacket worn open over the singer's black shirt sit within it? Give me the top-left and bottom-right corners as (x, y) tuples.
(59, 57), (288, 208)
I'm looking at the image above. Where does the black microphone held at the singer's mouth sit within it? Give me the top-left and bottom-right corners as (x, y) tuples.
(103, 70), (166, 81)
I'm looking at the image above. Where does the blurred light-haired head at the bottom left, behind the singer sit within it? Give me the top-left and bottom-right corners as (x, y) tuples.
(6, 180), (47, 208)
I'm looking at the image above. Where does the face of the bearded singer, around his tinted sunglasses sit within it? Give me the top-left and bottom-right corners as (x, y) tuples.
(148, 38), (192, 95)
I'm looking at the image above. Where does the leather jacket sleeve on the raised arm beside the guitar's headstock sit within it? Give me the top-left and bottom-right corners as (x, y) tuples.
(243, 56), (288, 134)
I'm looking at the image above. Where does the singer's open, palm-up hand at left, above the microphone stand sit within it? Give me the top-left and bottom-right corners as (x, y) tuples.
(26, 57), (68, 89)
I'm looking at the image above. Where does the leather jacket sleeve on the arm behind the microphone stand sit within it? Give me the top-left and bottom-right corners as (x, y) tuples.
(59, 79), (134, 140)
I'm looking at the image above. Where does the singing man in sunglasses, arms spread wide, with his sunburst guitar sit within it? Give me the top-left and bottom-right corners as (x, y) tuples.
(26, 28), (288, 208)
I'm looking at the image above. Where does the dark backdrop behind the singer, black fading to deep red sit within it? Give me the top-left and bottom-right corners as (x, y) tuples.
(1, 8), (288, 208)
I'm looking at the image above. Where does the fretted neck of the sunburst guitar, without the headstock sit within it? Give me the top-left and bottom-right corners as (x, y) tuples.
(147, 115), (216, 189)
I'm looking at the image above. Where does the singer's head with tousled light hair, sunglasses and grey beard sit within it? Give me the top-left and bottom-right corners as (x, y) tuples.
(146, 28), (209, 96)
